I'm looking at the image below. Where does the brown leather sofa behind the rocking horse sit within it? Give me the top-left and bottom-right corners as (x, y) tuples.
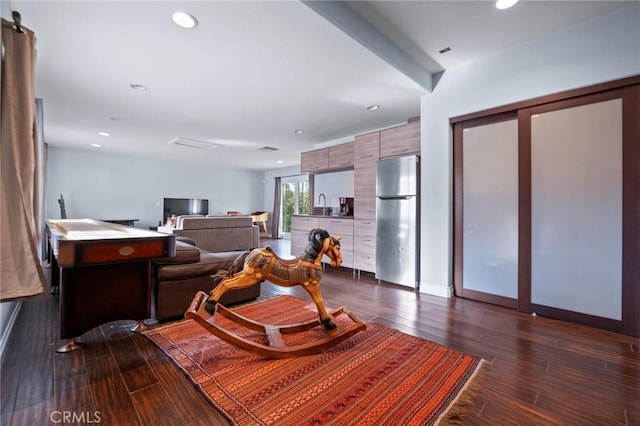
(152, 217), (260, 321)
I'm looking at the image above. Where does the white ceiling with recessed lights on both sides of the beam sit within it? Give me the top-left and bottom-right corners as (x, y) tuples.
(11, 0), (637, 170)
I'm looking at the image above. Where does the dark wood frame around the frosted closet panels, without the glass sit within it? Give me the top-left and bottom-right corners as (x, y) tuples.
(450, 76), (640, 336)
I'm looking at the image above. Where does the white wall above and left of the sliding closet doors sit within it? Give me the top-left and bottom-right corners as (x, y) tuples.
(420, 4), (640, 296)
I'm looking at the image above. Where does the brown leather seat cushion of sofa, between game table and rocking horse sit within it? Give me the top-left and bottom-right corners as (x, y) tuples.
(157, 250), (244, 281)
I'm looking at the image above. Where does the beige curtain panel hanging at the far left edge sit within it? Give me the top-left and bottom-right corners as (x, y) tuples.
(0, 19), (44, 301)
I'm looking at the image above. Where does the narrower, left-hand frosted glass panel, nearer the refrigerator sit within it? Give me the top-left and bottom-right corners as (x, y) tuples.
(462, 120), (518, 299)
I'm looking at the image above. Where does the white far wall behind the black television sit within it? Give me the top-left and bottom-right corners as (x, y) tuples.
(45, 146), (265, 228)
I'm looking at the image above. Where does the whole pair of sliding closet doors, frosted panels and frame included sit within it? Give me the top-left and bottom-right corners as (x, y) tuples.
(450, 75), (640, 336)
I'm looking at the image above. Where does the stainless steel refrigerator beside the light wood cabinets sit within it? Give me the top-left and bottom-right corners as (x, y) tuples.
(376, 155), (420, 290)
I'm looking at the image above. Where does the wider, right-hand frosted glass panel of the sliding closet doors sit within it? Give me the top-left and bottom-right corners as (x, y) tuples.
(531, 99), (622, 320)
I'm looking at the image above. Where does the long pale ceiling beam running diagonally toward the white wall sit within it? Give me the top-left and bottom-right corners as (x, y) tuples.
(302, 0), (432, 91)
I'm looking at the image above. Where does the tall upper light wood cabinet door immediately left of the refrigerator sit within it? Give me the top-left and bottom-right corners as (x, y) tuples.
(353, 132), (380, 219)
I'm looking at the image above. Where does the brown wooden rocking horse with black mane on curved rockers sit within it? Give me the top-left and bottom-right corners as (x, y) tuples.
(185, 229), (366, 358)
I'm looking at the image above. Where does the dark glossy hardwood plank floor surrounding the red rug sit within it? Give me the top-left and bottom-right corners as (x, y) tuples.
(0, 241), (640, 426)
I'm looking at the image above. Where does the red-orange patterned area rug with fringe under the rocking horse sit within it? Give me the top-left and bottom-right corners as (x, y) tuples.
(146, 296), (484, 426)
